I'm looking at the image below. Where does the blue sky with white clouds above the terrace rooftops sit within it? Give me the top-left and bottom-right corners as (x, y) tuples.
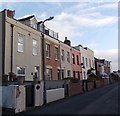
(0, 0), (118, 70)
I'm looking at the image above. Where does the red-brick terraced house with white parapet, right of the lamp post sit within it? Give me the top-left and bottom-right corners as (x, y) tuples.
(45, 28), (61, 80)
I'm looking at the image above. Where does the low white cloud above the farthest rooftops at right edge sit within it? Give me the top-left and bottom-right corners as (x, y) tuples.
(94, 49), (118, 71)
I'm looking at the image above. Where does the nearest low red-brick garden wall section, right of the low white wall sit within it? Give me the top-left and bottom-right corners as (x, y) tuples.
(69, 82), (83, 96)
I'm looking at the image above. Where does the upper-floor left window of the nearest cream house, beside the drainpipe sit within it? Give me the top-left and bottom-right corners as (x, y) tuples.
(17, 33), (25, 53)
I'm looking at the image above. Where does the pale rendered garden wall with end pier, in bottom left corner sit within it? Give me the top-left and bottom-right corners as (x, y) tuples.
(2, 85), (26, 113)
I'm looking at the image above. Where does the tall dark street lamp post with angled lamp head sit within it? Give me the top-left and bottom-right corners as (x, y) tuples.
(40, 17), (54, 104)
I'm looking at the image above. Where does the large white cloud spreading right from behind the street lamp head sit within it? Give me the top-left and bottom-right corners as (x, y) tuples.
(46, 9), (118, 40)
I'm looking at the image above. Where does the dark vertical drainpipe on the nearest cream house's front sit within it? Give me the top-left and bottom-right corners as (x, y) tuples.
(10, 24), (14, 73)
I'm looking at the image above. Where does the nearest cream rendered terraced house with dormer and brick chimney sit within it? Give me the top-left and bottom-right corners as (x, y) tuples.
(0, 9), (41, 81)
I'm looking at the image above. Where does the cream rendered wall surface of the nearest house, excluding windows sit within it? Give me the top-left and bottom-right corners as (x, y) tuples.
(5, 17), (41, 81)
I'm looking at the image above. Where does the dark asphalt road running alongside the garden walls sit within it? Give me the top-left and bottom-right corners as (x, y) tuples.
(23, 83), (120, 114)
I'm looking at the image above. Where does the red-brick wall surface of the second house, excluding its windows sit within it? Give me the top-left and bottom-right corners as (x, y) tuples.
(45, 41), (60, 80)
